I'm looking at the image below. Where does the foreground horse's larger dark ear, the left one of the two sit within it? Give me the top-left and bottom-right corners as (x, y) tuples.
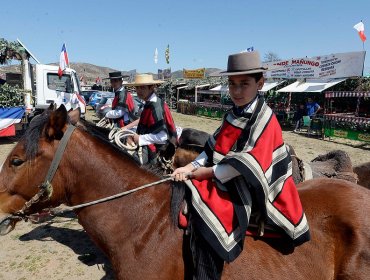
(45, 104), (68, 140)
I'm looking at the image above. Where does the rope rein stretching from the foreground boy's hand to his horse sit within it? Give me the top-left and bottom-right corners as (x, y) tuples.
(50, 177), (173, 215)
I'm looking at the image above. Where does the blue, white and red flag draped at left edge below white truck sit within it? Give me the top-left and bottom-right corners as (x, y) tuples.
(0, 107), (25, 137)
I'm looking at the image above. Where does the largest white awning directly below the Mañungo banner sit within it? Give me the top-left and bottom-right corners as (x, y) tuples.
(277, 79), (346, 92)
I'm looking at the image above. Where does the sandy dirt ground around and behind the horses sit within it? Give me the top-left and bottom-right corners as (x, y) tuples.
(0, 108), (370, 280)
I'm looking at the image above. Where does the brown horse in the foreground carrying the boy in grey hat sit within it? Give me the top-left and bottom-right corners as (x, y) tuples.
(0, 107), (370, 279)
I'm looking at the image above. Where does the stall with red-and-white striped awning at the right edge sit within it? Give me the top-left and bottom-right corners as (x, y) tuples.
(324, 91), (370, 142)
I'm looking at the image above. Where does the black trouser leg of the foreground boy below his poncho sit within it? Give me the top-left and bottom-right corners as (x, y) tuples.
(190, 226), (224, 280)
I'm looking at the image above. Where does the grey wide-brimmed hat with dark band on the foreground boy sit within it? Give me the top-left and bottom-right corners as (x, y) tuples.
(218, 51), (267, 76)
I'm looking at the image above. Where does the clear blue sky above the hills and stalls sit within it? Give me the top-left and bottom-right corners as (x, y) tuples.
(0, 0), (370, 73)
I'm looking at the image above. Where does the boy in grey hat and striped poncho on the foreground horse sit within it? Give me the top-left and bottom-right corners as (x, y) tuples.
(172, 51), (310, 279)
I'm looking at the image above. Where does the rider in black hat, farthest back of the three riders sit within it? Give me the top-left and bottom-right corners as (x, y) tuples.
(105, 72), (138, 128)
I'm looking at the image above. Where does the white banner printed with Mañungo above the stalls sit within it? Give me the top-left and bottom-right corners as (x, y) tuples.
(263, 51), (366, 79)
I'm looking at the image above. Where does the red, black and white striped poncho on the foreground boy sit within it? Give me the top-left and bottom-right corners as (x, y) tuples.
(186, 97), (310, 262)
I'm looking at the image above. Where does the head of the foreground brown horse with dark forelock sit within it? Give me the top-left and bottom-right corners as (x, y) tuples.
(0, 106), (72, 235)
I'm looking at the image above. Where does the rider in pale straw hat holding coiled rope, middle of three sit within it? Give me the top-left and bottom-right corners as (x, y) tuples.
(125, 74), (177, 164)
